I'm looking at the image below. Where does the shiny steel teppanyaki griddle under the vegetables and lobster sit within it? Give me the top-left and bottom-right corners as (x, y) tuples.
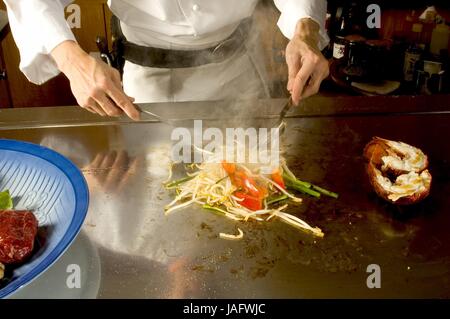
(0, 97), (450, 298)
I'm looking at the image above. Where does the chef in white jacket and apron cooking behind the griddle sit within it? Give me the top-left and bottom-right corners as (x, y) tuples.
(4, 0), (328, 119)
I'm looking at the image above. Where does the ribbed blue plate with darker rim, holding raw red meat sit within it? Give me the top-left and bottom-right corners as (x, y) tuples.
(0, 139), (89, 298)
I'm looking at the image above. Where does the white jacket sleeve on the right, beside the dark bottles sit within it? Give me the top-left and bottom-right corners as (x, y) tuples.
(274, 0), (330, 50)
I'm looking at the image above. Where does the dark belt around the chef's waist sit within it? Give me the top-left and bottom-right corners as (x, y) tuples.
(111, 16), (251, 69)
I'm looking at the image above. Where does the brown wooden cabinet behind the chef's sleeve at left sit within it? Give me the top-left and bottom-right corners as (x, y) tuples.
(0, 0), (110, 107)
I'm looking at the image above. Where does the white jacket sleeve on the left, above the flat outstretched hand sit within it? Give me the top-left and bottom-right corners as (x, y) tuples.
(4, 0), (75, 84)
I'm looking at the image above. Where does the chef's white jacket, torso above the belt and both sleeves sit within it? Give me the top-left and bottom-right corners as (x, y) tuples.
(4, 0), (328, 84)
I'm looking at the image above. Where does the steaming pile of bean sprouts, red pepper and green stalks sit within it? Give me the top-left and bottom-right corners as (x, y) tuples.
(165, 161), (338, 239)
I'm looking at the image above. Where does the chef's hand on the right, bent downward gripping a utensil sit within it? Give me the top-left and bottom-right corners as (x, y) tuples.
(286, 18), (329, 105)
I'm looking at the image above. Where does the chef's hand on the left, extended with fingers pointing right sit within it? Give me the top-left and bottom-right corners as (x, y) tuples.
(51, 41), (139, 120)
